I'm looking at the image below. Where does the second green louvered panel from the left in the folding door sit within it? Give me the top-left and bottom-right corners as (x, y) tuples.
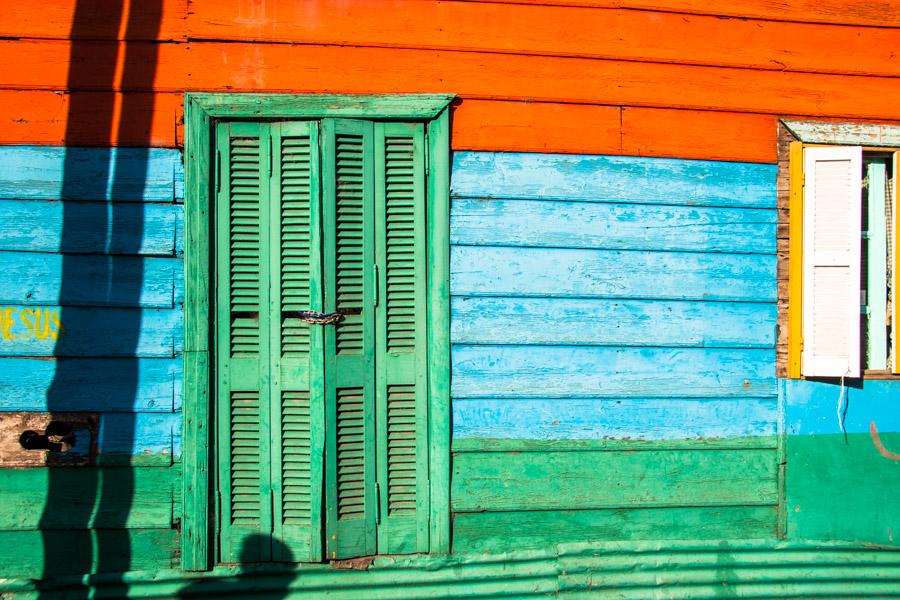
(268, 122), (325, 561)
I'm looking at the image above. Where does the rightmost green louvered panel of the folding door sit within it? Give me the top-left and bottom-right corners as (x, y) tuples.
(375, 123), (428, 554)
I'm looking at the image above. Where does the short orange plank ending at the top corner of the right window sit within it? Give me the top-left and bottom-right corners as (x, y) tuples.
(622, 108), (778, 162)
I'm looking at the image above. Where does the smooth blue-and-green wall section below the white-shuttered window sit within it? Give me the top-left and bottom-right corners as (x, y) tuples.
(782, 380), (900, 546)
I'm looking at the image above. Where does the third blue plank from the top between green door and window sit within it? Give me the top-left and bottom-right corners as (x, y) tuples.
(450, 246), (777, 302)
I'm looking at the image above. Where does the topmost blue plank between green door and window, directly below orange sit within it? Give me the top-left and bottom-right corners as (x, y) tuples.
(451, 152), (778, 208)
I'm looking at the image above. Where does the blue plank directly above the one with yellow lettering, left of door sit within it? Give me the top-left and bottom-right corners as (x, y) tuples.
(0, 252), (183, 308)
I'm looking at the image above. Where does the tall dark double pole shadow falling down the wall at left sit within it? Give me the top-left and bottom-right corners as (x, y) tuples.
(40, 0), (162, 598)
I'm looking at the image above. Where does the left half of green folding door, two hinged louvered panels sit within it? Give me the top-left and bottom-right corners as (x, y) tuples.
(216, 123), (324, 562)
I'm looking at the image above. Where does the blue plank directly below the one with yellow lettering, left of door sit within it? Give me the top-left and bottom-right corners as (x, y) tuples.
(0, 358), (181, 412)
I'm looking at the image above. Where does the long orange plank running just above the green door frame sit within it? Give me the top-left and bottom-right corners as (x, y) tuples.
(0, 41), (900, 119)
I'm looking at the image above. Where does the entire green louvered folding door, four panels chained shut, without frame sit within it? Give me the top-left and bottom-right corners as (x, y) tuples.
(215, 119), (429, 562)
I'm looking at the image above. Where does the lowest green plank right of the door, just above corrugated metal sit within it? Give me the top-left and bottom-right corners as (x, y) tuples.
(453, 506), (776, 553)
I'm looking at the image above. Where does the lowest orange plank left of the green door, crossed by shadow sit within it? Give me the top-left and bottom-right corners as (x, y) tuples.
(0, 90), (184, 147)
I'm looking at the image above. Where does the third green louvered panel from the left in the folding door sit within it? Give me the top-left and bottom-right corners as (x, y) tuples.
(322, 119), (377, 559)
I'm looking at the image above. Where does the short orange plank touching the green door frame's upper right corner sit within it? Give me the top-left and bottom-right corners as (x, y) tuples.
(450, 100), (621, 154)
